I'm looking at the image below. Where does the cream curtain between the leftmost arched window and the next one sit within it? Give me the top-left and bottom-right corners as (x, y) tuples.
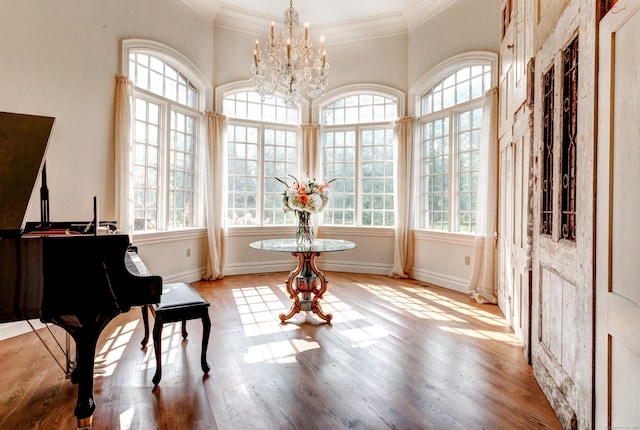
(204, 112), (227, 281)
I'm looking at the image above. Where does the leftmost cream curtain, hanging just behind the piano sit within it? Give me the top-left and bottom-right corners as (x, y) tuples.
(115, 75), (133, 241)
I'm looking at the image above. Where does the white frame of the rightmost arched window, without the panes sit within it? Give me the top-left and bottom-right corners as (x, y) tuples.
(409, 51), (498, 235)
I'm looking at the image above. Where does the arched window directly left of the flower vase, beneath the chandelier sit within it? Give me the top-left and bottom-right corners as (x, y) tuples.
(221, 86), (301, 226)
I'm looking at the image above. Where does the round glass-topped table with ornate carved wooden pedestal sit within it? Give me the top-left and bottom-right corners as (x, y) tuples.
(249, 239), (357, 324)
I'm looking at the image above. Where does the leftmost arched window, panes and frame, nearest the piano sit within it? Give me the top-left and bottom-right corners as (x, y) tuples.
(123, 40), (208, 232)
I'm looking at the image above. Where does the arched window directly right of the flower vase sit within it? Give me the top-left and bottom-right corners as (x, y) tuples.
(320, 86), (404, 227)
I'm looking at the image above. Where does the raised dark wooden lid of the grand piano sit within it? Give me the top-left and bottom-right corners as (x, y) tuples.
(0, 112), (55, 232)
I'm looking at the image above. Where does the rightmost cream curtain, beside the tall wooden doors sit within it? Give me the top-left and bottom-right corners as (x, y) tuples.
(468, 87), (498, 303)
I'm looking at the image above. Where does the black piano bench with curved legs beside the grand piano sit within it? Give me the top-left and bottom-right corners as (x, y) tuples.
(142, 282), (211, 386)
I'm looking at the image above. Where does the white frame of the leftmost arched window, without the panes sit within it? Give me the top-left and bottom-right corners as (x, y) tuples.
(121, 39), (212, 235)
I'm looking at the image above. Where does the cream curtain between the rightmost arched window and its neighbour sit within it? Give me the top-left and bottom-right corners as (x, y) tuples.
(389, 117), (414, 278)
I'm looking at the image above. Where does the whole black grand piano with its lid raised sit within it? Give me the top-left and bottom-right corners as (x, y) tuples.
(0, 112), (162, 429)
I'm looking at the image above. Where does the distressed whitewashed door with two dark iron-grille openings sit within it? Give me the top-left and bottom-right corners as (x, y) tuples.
(531, 1), (597, 429)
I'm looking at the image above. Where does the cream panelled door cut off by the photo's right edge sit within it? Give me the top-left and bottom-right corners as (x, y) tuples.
(594, 0), (640, 429)
